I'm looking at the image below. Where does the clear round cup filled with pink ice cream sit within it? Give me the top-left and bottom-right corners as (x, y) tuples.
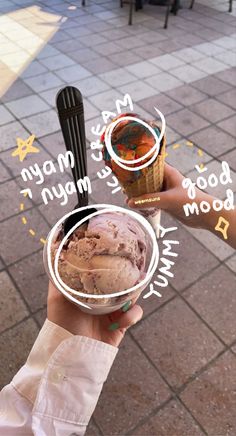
(44, 205), (159, 315)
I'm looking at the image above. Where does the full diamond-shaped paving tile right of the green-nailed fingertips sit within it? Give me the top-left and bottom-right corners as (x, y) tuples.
(132, 298), (222, 388)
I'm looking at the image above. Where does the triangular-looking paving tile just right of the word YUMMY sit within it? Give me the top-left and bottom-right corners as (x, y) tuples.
(169, 222), (219, 291)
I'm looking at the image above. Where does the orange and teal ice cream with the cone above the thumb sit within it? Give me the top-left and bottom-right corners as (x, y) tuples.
(101, 113), (166, 198)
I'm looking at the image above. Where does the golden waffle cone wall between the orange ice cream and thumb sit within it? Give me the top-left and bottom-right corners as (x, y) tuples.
(123, 137), (166, 198)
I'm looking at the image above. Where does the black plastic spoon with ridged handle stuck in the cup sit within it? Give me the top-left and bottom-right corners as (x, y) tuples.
(56, 86), (97, 234)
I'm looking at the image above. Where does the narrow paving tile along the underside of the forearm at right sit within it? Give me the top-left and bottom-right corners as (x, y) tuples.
(186, 223), (234, 261)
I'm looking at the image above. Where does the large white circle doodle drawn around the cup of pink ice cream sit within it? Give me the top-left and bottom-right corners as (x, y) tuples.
(47, 204), (159, 304)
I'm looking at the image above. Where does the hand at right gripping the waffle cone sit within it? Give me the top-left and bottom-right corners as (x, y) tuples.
(128, 163), (211, 228)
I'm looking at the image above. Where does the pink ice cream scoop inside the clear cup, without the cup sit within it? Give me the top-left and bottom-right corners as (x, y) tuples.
(52, 212), (147, 294)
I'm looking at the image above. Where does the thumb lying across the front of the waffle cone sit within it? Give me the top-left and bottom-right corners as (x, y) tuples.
(128, 191), (170, 209)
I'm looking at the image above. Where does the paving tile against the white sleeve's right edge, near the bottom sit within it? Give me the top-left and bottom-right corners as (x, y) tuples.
(94, 336), (170, 435)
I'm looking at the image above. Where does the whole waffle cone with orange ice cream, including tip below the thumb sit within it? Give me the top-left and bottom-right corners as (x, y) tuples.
(101, 109), (166, 237)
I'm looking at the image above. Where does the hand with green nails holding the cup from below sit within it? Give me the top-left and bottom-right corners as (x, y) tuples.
(47, 282), (143, 347)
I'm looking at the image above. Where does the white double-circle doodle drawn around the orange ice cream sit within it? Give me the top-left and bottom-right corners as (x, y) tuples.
(104, 108), (166, 171)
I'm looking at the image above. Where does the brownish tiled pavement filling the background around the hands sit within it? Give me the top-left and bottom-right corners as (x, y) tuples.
(0, 0), (236, 436)
